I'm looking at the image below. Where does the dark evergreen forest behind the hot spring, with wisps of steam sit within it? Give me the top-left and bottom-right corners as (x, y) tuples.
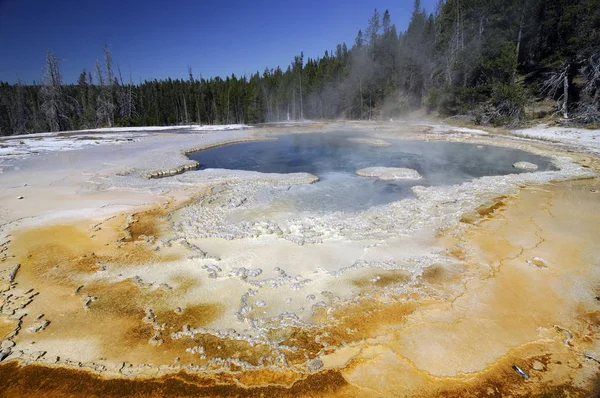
(0, 0), (600, 135)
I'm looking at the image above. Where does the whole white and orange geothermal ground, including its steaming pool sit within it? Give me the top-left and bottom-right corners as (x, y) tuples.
(0, 122), (600, 397)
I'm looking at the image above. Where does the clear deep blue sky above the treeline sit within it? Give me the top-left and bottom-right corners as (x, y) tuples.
(0, 0), (437, 83)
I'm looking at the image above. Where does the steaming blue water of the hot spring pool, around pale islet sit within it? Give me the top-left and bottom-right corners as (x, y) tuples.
(189, 132), (555, 211)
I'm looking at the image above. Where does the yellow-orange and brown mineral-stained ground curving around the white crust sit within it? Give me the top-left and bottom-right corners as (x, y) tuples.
(0, 123), (600, 397)
